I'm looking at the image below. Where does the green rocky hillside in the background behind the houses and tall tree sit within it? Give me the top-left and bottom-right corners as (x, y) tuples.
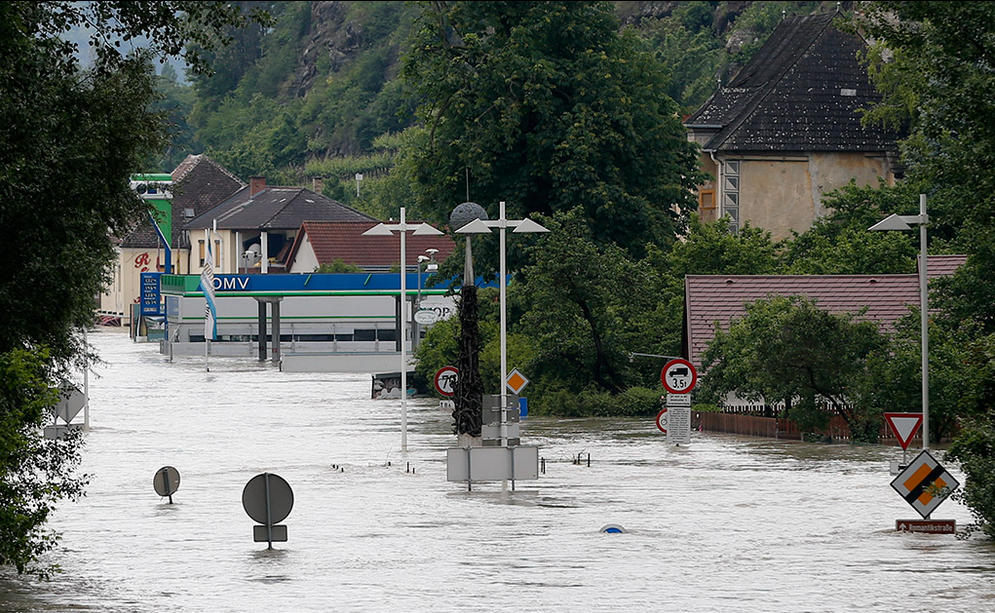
(158, 1), (836, 198)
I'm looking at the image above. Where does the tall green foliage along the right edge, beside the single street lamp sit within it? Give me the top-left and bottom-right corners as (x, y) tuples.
(856, 2), (995, 535)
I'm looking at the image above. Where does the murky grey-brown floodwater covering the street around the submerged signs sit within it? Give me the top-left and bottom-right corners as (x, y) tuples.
(0, 331), (995, 613)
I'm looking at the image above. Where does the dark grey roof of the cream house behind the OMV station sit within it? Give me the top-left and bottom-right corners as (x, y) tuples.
(185, 186), (376, 230)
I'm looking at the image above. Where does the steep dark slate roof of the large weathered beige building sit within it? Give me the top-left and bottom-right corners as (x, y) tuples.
(685, 13), (897, 152)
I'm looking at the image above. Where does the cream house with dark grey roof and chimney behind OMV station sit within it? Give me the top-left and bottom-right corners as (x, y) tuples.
(185, 177), (377, 273)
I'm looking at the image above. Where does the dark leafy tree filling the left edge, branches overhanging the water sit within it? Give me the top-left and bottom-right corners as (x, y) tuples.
(0, 1), (262, 571)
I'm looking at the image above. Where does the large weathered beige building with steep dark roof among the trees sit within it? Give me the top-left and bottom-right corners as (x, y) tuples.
(684, 13), (899, 238)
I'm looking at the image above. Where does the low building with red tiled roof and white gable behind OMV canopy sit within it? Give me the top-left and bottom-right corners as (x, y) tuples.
(287, 221), (456, 272)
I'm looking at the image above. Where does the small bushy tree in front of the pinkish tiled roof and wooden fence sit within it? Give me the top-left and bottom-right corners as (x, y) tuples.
(702, 297), (889, 442)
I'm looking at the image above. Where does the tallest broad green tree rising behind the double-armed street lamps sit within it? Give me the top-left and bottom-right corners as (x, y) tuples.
(402, 2), (700, 268)
